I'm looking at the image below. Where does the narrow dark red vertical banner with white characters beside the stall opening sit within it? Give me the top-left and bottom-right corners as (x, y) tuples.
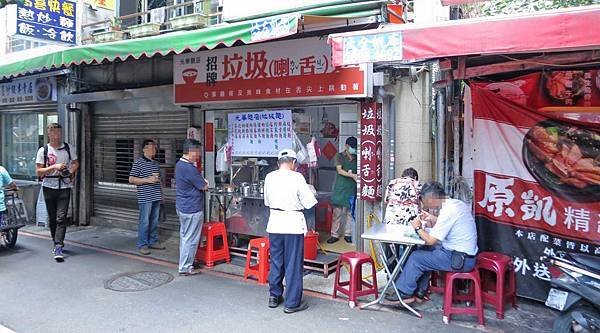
(359, 102), (383, 202)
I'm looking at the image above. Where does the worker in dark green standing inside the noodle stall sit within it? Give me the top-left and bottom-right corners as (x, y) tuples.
(327, 136), (358, 244)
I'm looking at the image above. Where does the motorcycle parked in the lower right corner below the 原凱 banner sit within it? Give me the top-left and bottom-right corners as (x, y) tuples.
(541, 252), (600, 333)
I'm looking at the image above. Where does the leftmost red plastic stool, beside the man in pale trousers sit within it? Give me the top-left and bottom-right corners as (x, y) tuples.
(196, 222), (231, 267)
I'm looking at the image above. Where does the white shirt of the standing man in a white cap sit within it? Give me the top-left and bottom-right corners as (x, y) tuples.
(264, 169), (317, 234)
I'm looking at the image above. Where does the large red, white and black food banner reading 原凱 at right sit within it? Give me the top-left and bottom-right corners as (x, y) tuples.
(471, 71), (600, 300)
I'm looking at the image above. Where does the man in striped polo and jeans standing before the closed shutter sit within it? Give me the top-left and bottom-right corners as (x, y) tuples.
(129, 140), (165, 255)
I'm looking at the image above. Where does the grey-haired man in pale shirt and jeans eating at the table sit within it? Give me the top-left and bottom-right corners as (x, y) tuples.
(386, 181), (477, 304)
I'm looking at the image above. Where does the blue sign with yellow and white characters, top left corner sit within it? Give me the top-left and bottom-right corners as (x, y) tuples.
(16, 0), (77, 44)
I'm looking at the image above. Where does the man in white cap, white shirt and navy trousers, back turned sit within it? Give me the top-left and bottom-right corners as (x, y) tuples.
(264, 149), (317, 313)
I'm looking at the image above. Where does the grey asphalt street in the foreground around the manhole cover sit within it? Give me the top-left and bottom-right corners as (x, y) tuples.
(0, 235), (482, 333)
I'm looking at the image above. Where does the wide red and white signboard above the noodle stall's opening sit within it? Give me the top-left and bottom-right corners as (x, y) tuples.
(173, 37), (372, 104)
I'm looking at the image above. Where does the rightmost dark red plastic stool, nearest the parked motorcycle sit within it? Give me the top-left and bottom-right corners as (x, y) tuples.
(477, 252), (517, 319)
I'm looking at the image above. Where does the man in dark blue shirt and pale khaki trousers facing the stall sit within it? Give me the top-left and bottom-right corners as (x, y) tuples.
(175, 139), (208, 275)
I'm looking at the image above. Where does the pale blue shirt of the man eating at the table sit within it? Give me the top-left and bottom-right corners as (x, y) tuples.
(430, 199), (477, 255)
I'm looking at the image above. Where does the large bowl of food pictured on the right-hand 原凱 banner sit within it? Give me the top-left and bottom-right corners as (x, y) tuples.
(523, 120), (600, 202)
